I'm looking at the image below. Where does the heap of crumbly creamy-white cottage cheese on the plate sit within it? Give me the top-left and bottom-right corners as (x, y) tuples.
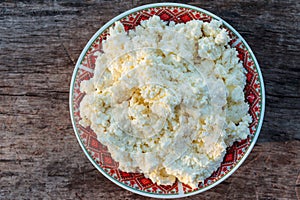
(80, 16), (252, 188)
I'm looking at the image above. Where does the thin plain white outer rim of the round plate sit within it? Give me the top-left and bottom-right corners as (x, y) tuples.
(69, 3), (265, 199)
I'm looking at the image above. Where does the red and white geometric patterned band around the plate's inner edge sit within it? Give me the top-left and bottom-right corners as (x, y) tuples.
(73, 6), (261, 194)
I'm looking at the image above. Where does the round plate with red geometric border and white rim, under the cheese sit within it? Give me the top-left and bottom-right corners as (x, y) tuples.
(70, 3), (265, 198)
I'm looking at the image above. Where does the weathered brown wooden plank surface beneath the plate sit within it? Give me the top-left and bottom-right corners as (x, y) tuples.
(0, 0), (300, 199)
